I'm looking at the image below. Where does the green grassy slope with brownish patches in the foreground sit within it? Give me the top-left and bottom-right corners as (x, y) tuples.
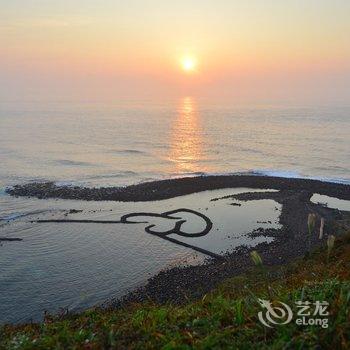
(0, 233), (350, 349)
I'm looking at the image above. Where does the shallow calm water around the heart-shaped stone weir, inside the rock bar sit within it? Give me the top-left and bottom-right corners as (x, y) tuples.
(0, 188), (281, 322)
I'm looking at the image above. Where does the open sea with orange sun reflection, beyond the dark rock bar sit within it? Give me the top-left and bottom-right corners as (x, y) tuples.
(0, 97), (350, 187)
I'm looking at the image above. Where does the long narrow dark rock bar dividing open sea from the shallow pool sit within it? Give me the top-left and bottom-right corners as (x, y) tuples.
(5, 175), (350, 202)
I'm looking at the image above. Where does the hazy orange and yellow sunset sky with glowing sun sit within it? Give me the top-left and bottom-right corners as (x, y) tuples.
(0, 0), (350, 104)
